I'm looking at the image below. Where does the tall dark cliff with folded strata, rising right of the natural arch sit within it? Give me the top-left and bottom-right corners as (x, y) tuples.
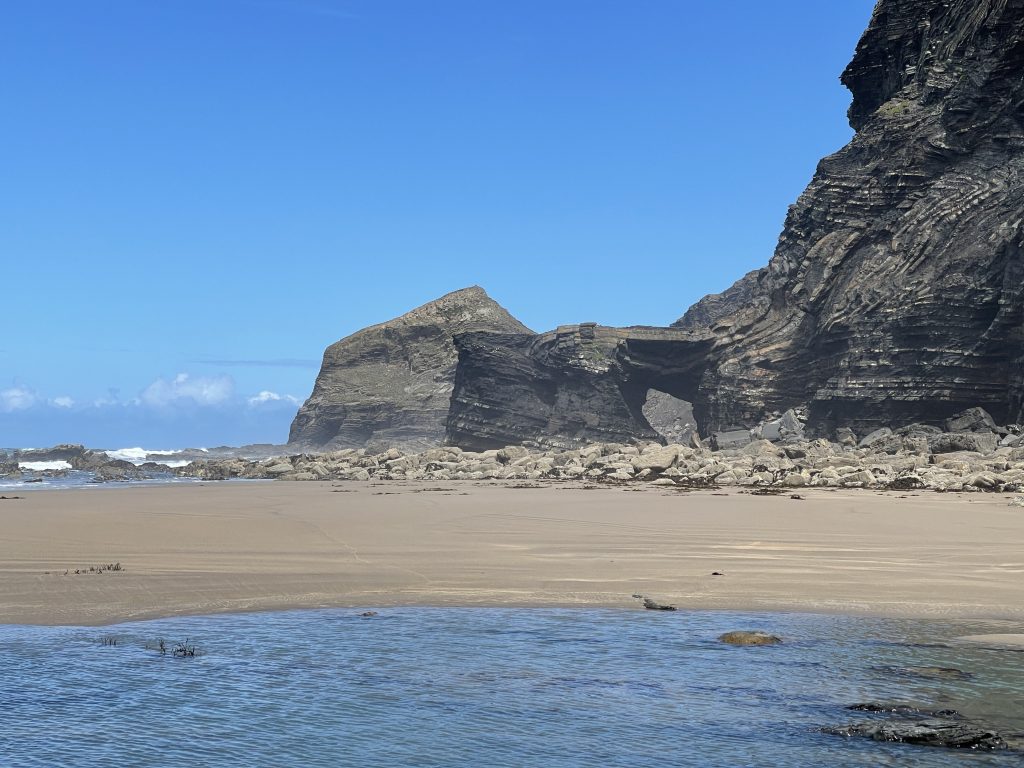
(689, 0), (1024, 431)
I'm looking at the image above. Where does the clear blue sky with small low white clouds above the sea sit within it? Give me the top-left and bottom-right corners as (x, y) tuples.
(0, 0), (873, 447)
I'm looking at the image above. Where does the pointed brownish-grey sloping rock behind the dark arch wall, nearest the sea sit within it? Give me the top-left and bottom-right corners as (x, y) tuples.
(289, 287), (529, 450)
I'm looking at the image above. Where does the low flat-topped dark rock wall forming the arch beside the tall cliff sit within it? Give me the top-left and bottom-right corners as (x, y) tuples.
(447, 323), (714, 451)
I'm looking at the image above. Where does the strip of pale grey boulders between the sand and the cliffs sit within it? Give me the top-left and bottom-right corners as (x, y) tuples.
(169, 409), (1024, 493)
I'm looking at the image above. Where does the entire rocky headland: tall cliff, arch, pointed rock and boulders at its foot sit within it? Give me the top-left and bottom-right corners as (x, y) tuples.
(16, 0), (1024, 492)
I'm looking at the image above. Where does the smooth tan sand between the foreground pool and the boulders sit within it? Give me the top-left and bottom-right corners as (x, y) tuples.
(0, 481), (1024, 632)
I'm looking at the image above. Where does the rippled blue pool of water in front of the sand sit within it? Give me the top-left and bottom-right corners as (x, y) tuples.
(0, 608), (1024, 768)
